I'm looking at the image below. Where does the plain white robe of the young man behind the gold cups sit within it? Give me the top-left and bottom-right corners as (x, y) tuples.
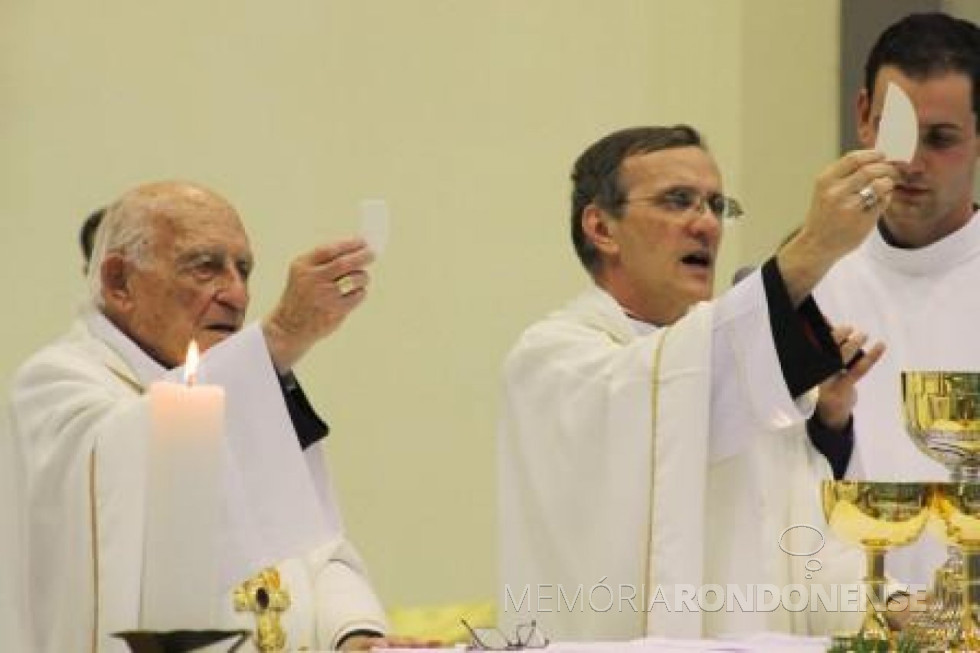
(815, 215), (980, 584)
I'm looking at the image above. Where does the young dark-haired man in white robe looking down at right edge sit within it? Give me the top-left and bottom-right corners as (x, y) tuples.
(815, 13), (980, 584)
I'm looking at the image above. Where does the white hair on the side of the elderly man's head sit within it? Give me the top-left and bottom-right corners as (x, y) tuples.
(87, 193), (155, 309)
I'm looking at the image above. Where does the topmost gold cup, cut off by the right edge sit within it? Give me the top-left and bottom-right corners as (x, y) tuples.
(902, 372), (980, 482)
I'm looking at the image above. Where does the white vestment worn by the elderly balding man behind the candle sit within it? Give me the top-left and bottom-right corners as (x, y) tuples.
(10, 313), (384, 653)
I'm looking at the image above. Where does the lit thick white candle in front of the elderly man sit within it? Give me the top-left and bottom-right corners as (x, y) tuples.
(140, 342), (225, 630)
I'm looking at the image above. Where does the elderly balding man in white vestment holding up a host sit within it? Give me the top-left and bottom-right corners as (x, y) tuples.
(8, 182), (410, 653)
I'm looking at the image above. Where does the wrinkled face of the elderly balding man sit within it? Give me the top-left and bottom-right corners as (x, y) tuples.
(107, 195), (252, 367)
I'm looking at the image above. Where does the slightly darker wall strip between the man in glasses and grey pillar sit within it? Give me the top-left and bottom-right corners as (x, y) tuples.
(740, 0), (840, 261)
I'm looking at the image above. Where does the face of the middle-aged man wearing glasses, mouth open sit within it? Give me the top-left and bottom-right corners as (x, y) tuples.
(603, 147), (722, 324)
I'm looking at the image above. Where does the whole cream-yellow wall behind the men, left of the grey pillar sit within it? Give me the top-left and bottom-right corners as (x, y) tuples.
(0, 0), (839, 606)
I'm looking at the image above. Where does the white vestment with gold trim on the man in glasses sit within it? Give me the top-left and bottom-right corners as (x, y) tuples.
(499, 273), (857, 640)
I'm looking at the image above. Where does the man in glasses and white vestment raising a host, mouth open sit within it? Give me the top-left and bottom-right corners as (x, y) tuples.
(499, 125), (896, 640)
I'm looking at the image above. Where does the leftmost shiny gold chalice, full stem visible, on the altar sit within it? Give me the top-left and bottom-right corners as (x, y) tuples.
(822, 481), (932, 642)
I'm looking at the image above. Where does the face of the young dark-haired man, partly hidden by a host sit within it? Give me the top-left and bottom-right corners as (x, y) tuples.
(858, 66), (980, 247)
